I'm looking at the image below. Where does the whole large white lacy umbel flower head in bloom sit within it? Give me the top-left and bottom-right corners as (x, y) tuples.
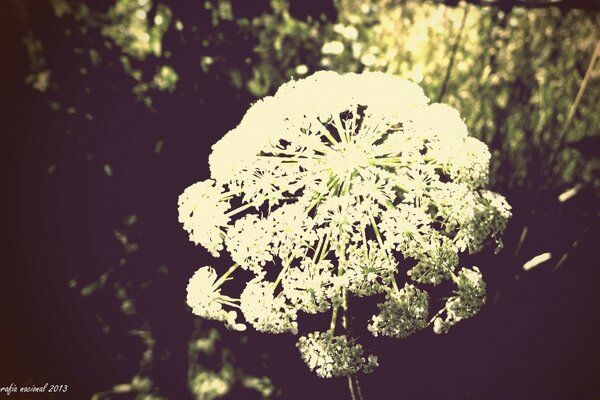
(179, 72), (510, 377)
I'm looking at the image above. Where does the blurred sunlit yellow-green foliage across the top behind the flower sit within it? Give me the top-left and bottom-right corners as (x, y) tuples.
(35, 0), (600, 194)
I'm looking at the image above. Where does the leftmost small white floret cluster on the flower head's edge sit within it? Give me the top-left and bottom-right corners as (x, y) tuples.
(178, 179), (229, 257)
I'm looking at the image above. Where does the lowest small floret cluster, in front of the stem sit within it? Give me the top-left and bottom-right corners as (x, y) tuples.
(296, 331), (377, 378)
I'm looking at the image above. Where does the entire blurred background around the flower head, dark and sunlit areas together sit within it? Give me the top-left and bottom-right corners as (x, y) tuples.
(0, 0), (600, 400)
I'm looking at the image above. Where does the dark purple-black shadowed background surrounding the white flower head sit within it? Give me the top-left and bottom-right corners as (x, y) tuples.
(0, 1), (600, 400)
